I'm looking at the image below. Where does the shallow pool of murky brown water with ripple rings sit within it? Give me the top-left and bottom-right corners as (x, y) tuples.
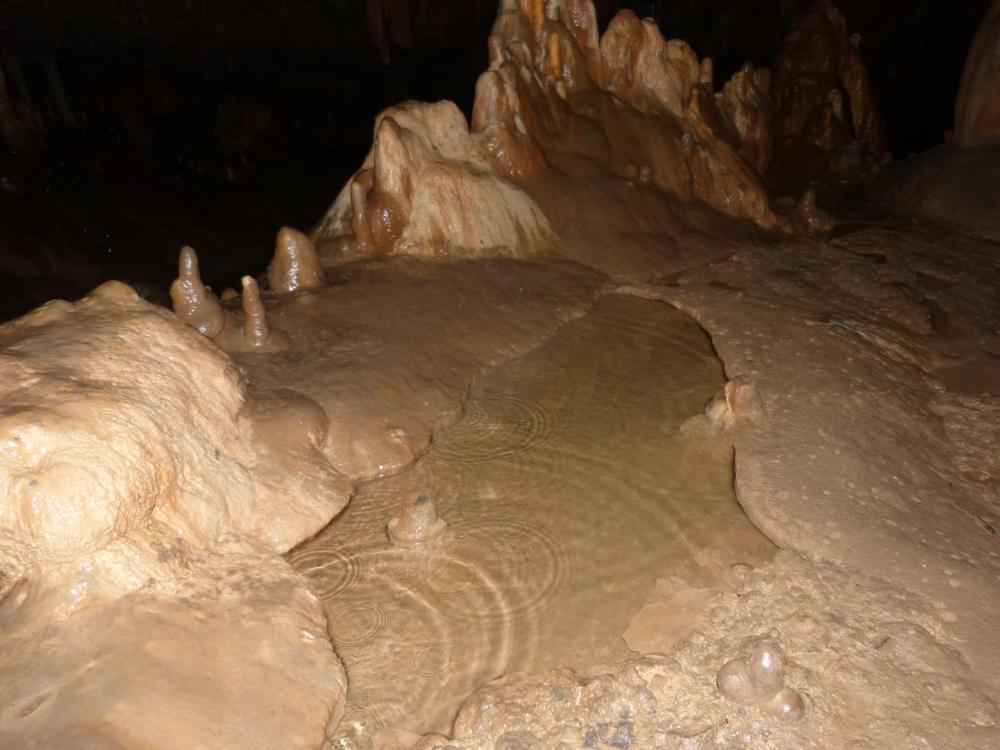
(290, 296), (772, 747)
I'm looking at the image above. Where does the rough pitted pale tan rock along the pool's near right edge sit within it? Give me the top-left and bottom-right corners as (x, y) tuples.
(428, 552), (998, 750)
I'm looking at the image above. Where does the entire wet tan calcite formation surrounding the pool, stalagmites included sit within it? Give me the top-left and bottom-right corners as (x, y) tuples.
(0, 0), (1000, 750)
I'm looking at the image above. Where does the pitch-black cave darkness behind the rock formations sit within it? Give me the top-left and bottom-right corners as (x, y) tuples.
(0, 0), (988, 319)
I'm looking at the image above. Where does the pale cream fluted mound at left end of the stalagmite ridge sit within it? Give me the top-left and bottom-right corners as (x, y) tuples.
(314, 102), (551, 258)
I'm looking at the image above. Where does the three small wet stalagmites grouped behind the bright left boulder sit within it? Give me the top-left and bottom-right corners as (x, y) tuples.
(170, 227), (326, 351)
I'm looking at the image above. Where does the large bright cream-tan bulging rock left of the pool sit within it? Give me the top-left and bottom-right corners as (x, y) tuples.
(0, 284), (350, 748)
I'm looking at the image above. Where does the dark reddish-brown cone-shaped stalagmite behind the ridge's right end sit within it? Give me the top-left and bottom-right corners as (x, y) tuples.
(767, 0), (887, 191)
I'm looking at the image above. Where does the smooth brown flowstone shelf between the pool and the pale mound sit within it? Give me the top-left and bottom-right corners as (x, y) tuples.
(233, 257), (604, 479)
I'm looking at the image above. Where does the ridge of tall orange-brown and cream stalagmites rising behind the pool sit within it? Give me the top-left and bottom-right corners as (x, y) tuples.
(313, 0), (820, 259)
